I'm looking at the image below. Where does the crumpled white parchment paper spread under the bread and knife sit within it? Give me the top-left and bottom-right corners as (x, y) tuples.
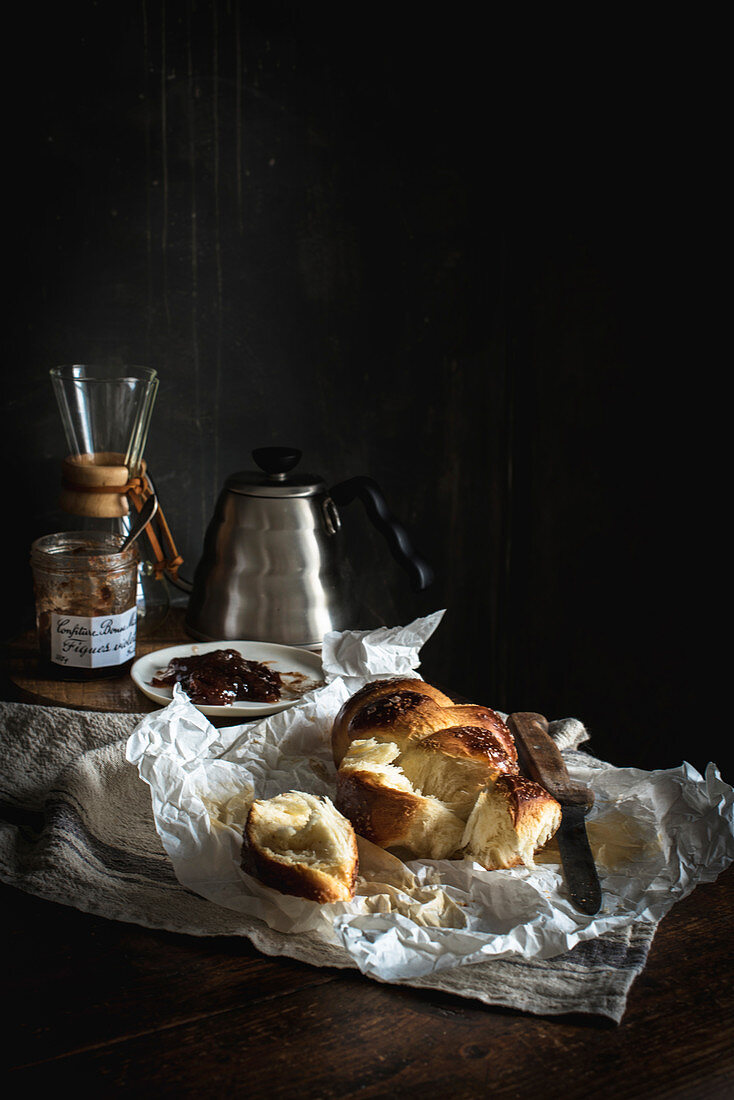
(127, 612), (734, 981)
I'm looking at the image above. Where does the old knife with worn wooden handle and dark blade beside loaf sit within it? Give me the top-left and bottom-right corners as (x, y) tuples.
(507, 712), (602, 916)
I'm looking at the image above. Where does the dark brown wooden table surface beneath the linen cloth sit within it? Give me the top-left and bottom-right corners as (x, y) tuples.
(1, 615), (734, 1100)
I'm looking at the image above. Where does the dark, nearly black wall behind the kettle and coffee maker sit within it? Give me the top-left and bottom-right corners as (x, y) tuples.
(3, 8), (732, 778)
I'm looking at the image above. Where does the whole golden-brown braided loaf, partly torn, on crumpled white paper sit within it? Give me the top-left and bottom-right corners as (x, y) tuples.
(331, 678), (560, 870)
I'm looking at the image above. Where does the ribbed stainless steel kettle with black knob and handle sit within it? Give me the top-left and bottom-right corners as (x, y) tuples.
(186, 447), (432, 646)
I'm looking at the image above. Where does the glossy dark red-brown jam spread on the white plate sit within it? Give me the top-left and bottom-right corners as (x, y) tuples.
(151, 649), (283, 706)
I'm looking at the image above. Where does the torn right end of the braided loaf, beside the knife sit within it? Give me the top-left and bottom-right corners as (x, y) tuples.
(461, 776), (561, 871)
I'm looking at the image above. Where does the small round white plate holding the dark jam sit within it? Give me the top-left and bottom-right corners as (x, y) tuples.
(130, 641), (324, 718)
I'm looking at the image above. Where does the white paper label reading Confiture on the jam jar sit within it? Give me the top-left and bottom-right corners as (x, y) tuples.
(51, 607), (138, 669)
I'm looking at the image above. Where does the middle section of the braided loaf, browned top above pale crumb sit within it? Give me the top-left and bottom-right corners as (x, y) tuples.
(399, 726), (517, 821)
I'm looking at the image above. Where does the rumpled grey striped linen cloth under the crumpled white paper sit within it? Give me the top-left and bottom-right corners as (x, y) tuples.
(0, 702), (657, 1023)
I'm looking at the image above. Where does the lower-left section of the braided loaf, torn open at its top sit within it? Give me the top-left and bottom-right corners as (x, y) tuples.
(337, 738), (464, 859)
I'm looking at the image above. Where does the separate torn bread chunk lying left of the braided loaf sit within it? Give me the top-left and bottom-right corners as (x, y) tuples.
(242, 791), (359, 903)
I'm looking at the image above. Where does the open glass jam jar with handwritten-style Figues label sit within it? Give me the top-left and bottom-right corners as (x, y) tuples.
(31, 531), (138, 680)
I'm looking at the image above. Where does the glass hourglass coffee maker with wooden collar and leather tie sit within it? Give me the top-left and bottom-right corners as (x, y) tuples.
(51, 364), (180, 634)
